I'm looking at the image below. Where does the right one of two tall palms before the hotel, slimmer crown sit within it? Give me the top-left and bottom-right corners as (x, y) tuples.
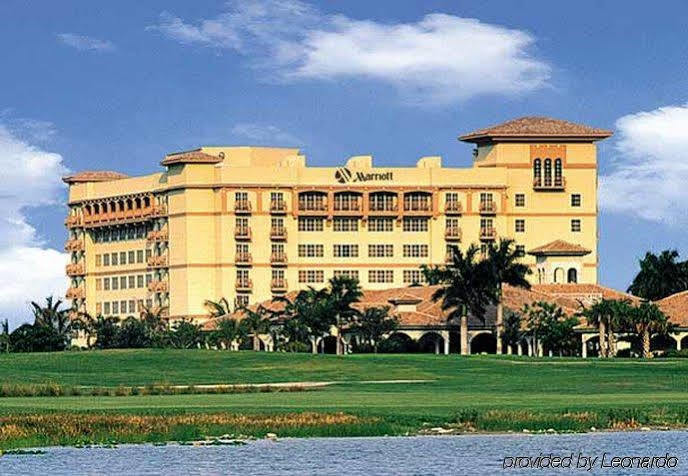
(487, 239), (531, 354)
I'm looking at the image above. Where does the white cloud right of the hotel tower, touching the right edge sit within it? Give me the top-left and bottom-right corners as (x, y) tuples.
(600, 104), (688, 224)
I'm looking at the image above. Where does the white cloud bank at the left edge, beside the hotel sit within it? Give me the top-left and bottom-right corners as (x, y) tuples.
(0, 123), (67, 326)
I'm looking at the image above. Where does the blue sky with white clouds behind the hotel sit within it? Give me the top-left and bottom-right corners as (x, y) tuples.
(0, 0), (688, 325)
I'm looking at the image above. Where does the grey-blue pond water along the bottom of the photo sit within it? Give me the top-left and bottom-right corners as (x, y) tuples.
(0, 431), (688, 476)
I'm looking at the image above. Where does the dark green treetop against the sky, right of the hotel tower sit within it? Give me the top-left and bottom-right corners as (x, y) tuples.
(628, 250), (688, 301)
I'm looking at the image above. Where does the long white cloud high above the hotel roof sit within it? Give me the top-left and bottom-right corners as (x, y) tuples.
(149, 0), (551, 103)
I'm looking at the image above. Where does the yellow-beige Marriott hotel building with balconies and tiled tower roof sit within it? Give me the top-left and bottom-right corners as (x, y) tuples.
(64, 117), (611, 320)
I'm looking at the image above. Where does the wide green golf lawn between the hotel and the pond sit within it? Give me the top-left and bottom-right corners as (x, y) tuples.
(0, 350), (688, 443)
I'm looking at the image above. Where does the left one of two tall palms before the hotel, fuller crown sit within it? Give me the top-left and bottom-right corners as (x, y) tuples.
(432, 244), (495, 355)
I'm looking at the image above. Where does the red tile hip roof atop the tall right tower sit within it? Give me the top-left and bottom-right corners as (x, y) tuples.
(459, 116), (612, 142)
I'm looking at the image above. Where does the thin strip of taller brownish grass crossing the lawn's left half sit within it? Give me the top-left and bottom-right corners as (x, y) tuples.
(0, 382), (315, 398)
